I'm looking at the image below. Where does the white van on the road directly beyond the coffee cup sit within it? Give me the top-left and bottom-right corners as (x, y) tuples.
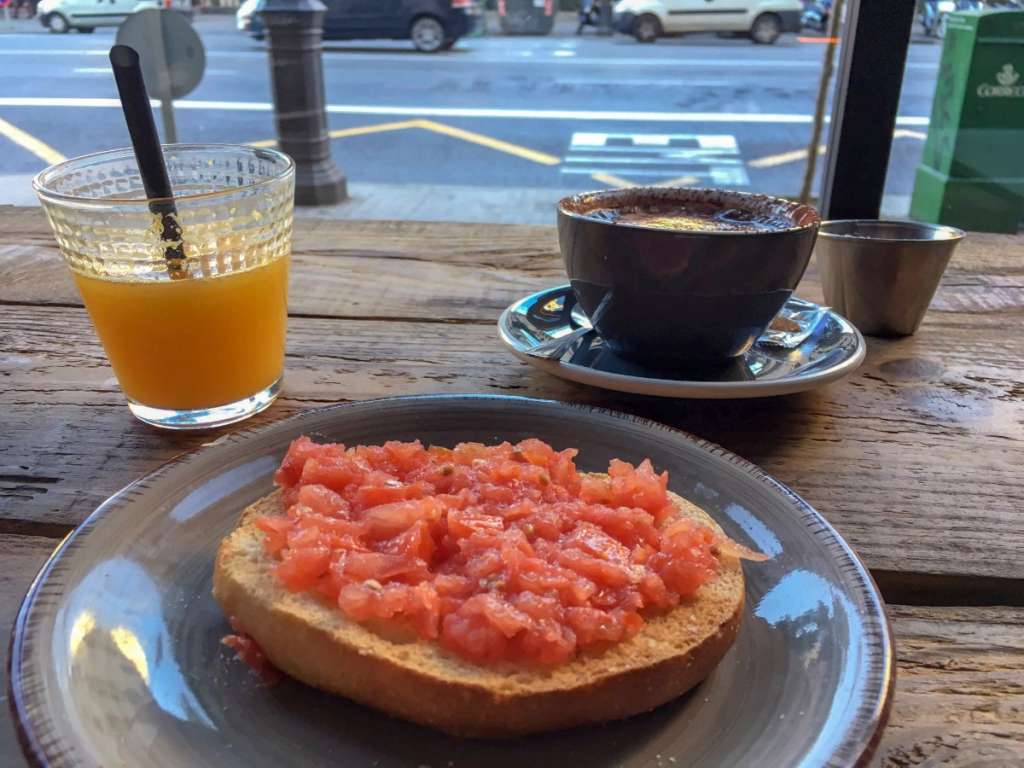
(614, 0), (804, 45)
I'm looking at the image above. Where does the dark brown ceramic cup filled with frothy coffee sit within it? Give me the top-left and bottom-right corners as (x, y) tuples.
(558, 187), (820, 368)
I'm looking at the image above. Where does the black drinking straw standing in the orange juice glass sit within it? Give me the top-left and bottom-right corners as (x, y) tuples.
(111, 45), (185, 270)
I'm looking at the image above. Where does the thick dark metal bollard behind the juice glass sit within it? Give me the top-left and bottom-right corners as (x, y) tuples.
(259, 0), (348, 206)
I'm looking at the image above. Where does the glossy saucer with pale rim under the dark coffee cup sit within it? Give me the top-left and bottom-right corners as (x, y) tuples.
(498, 285), (866, 399)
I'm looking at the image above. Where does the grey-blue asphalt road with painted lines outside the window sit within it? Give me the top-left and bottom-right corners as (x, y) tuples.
(0, 16), (940, 210)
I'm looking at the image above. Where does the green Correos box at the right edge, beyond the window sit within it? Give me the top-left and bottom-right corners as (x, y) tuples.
(910, 11), (1024, 232)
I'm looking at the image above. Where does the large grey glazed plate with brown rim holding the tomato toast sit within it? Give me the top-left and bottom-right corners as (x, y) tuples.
(10, 395), (893, 768)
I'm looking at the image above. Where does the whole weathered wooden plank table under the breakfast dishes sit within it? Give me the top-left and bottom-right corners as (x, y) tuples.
(0, 208), (1024, 768)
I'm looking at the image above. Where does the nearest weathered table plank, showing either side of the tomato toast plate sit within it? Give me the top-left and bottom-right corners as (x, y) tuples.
(0, 535), (1024, 768)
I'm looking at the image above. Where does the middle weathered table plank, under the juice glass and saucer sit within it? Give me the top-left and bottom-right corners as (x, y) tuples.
(0, 305), (1024, 581)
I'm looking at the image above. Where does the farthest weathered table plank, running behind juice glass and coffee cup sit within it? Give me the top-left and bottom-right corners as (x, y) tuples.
(0, 206), (1024, 328)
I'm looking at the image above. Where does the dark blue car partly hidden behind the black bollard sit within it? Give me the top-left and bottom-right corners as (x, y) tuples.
(249, 0), (480, 53)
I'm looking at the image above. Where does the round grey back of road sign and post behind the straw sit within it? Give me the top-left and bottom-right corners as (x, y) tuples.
(117, 8), (206, 144)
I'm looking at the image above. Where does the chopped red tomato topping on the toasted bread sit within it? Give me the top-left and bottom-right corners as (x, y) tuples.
(258, 437), (758, 664)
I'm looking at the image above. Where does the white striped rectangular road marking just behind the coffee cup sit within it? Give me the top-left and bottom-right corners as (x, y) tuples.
(561, 131), (751, 186)
